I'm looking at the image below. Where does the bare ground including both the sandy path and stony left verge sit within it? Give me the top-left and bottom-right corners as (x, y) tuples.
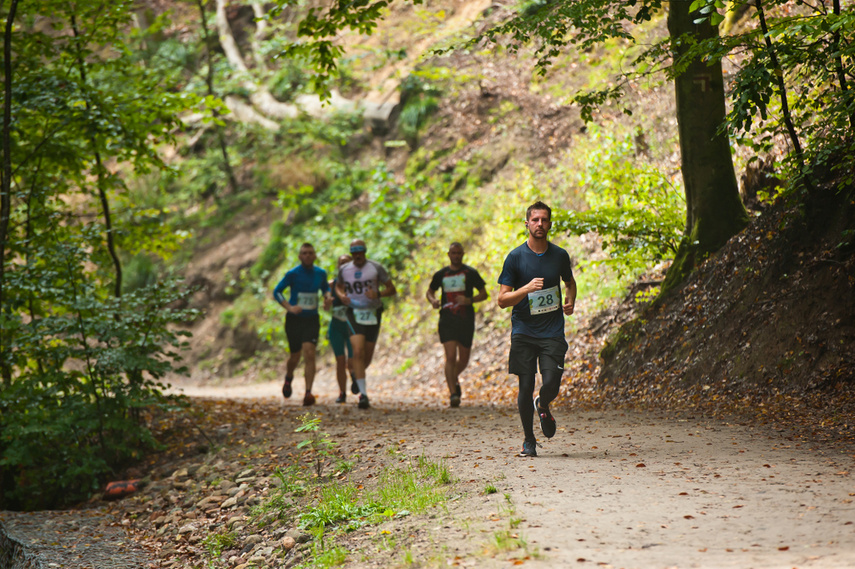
(5, 368), (855, 569)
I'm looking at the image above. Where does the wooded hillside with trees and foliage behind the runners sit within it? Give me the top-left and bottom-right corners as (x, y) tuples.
(0, 0), (855, 509)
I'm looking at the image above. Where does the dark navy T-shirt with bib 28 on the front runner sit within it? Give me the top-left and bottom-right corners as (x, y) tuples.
(499, 243), (573, 338)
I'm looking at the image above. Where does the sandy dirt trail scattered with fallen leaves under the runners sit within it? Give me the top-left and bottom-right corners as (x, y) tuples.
(166, 368), (855, 568)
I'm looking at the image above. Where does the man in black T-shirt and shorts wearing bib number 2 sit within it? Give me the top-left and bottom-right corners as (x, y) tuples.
(425, 242), (487, 407)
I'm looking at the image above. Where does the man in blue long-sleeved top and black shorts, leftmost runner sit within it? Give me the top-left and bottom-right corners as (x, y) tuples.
(273, 243), (332, 407)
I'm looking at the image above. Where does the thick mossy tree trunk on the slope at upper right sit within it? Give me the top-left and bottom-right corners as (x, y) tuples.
(662, 2), (749, 292)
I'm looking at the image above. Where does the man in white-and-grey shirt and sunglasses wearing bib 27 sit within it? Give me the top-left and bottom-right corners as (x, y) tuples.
(335, 239), (397, 409)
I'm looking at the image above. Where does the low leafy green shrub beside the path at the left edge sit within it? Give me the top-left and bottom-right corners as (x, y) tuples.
(0, 240), (192, 509)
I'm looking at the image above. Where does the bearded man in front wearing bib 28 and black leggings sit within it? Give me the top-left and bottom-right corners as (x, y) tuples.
(496, 201), (576, 456)
